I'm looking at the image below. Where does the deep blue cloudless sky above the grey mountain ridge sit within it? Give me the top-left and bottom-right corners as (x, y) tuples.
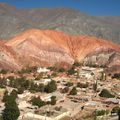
(0, 0), (120, 16)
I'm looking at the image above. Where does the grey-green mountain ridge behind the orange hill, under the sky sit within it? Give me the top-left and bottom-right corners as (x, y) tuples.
(0, 3), (120, 43)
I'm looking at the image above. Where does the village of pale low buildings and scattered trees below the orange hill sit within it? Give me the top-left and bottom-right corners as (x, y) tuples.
(0, 64), (120, 120)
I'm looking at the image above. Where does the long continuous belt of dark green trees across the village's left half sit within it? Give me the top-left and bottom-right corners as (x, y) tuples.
(0, 77), (57, 94)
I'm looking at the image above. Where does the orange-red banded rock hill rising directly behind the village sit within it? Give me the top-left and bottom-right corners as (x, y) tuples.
(0, 29), (120, 69)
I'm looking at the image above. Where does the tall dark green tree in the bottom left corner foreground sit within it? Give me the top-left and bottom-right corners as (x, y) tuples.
(2, 90), (20, 120)
